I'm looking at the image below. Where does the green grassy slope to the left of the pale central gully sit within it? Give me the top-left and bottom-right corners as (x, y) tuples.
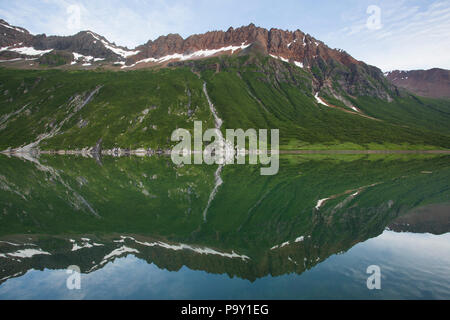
(0, 69), (213, 150)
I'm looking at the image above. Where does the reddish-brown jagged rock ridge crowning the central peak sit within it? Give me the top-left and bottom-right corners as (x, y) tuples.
(130, 24), (395, 102)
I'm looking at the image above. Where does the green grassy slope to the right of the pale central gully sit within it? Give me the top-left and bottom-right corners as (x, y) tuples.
(197, 57), (450, 149)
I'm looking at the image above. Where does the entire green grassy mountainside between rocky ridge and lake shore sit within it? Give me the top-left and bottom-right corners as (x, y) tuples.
(0, 55), (450, 150)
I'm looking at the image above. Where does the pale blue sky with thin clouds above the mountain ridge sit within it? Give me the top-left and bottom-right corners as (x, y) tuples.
(0, 0), (450, 71)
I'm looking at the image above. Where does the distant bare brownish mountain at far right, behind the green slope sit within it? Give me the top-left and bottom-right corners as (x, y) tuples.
(385, 68), (450, 98)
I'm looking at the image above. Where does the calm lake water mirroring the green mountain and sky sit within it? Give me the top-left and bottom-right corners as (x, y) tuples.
(0, 154), (450, 299)
